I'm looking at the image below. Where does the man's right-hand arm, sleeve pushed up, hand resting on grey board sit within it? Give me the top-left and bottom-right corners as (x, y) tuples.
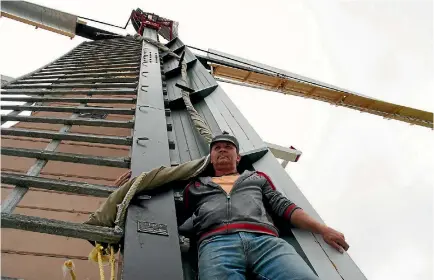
(257, 172), (349, 253)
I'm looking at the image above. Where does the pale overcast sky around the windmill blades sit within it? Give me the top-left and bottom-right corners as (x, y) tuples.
(0, 0), (434, 280)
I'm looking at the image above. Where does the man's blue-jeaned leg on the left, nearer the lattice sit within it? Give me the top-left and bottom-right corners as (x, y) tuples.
(198, 233), (247, 280)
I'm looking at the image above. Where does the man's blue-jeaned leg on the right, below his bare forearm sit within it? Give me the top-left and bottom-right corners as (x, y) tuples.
(248, 234), (319, 280)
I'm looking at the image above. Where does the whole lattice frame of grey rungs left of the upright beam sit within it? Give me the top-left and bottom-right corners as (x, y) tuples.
(1, 39), (141, 243)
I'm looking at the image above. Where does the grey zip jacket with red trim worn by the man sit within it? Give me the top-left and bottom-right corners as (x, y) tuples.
(183, 171), (299, 244)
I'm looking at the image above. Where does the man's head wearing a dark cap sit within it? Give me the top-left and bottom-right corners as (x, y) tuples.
(210, 132), (241, 176)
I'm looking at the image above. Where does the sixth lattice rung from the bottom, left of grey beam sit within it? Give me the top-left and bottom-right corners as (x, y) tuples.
(2, 105), (135, 115)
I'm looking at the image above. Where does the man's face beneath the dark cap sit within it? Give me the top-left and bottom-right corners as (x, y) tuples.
(211, 141), (241, 169)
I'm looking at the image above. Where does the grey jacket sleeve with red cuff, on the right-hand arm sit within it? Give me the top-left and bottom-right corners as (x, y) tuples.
(257, 172), (301, 222)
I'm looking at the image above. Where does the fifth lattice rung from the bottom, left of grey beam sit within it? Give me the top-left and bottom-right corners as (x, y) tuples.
(0, 114), (134, 128)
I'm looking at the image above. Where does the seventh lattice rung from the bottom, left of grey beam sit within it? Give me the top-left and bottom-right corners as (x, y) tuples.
(0, 96), (136, 104)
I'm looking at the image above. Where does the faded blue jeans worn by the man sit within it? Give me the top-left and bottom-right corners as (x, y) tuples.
(199, 232), (319, 280)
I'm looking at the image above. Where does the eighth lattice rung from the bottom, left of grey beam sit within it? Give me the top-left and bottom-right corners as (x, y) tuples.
(0, 89), (137, 95)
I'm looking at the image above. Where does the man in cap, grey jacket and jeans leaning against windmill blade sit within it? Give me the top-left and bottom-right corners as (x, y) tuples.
(105, 133), (349, 280)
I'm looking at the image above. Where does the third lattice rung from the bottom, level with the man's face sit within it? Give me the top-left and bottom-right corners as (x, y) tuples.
(0, 147), (130, 168)
